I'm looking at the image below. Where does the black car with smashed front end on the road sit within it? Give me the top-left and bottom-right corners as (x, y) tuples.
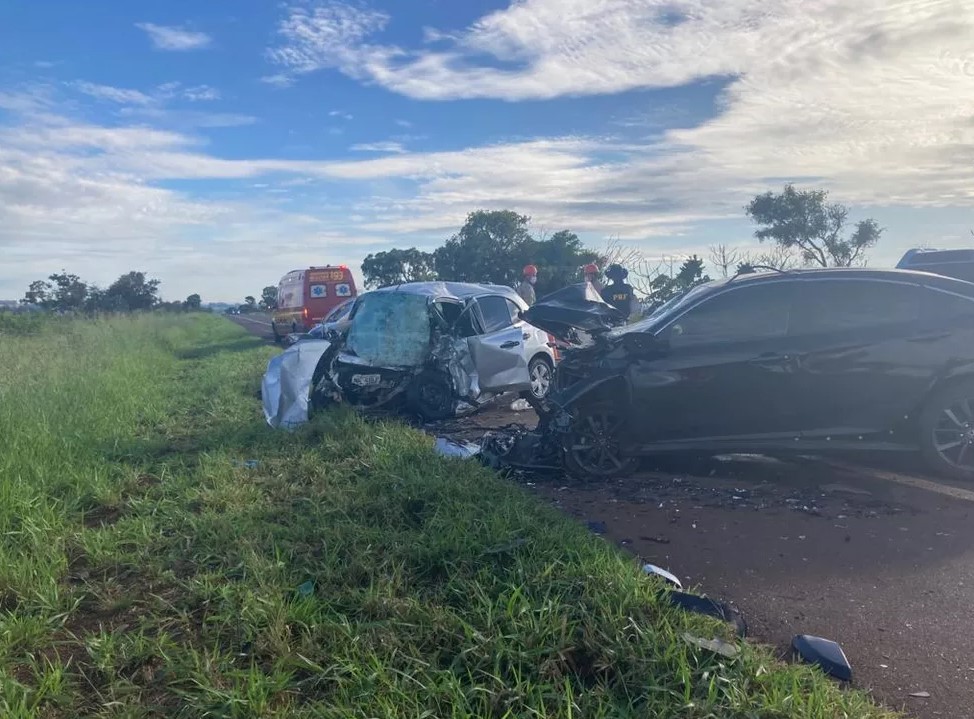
(524, 269), (974, 479)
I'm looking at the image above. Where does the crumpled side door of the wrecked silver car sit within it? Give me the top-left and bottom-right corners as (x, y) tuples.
(467, 295), (531, 392)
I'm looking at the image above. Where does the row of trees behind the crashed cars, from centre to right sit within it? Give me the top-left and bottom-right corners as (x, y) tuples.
(362, 184), (883, 304)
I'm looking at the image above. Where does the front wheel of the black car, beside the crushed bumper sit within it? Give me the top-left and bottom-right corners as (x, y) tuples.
(564, 402), (639, 480)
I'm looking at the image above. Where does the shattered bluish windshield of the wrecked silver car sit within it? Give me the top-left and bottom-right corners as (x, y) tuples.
(346, 292), (430, 367)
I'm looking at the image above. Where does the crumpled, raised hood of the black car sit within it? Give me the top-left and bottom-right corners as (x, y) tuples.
(521, 282), (624, 342)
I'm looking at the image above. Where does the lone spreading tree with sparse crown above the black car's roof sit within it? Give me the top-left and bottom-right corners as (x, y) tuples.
(745, 185), (883, 267)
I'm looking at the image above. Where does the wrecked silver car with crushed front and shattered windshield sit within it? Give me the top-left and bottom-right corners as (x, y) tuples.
(265, 282), (556, 426)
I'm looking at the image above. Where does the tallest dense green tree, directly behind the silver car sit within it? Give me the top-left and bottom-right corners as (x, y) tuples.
(433, 210), (531, 285)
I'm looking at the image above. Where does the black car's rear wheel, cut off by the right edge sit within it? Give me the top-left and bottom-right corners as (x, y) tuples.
(919, 379), (974, 482)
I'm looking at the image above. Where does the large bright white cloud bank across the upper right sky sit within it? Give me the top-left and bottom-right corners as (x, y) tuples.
(270, 0), (974, 214)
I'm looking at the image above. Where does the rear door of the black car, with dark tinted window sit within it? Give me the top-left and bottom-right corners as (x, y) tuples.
(789, 278), (943, 439)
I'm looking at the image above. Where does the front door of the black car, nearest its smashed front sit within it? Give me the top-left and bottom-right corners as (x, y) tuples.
(629, 280), (795, 445)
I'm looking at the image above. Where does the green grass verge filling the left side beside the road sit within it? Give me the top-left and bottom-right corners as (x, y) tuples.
(0, 315), (889, 719)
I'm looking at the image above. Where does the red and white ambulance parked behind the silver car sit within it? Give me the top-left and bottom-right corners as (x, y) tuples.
(271, 265), (358, 342)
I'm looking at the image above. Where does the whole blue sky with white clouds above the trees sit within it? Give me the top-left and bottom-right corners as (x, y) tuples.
(0, 0), (974, 300)
